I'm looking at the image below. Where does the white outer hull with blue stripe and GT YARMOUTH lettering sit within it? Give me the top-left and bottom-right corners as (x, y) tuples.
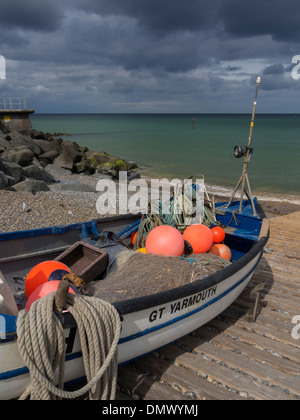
(0, 253), (262, 399)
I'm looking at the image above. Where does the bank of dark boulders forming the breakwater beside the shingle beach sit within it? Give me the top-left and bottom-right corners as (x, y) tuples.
(0, 130), (140, 192)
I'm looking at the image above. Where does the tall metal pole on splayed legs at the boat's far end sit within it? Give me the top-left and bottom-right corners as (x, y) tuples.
(227, 77), (261, 216)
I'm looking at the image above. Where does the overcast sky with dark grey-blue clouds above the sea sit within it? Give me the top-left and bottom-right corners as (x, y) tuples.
(0, 0), (300, 113)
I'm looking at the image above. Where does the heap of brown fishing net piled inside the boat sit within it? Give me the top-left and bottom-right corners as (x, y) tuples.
(87, 251), (231, 303)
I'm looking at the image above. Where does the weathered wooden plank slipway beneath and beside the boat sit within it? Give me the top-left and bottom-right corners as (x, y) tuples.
(117, 212), (300, 400)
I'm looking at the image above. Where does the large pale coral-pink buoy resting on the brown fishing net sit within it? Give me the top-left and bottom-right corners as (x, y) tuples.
(146, 225), (184, 257)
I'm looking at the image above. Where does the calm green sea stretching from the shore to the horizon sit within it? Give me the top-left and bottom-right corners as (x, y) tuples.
(31, 114), (300, 195)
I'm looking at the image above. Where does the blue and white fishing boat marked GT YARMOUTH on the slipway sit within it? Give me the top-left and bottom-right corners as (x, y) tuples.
(0, 199), (269, 399)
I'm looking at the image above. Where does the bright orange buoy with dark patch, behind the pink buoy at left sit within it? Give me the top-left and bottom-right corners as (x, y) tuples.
(25, 261), (71, 299)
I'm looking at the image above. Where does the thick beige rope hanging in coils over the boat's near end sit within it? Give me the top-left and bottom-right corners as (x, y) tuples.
(17, 292), (121, 400)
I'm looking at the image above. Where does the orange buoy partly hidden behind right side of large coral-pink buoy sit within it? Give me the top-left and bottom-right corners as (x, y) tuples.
(183, 225), (213, 254)
